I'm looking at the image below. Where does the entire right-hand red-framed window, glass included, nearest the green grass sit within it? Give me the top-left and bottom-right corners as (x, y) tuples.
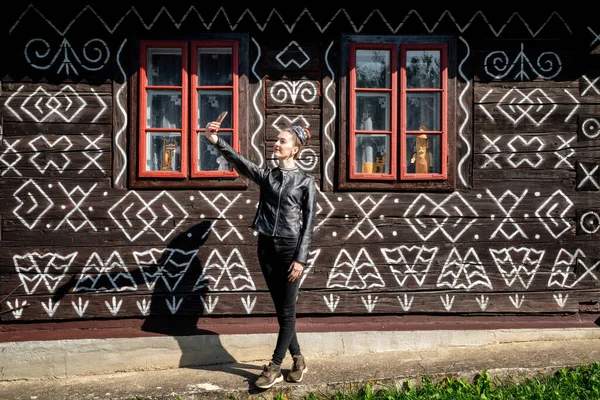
(340, 37), (451, 188)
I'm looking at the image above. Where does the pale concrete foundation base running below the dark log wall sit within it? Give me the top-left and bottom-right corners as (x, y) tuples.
(0, 328), (600, 381)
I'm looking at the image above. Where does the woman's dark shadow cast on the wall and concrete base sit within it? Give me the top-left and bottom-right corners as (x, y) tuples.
(134, 221), (259, 381)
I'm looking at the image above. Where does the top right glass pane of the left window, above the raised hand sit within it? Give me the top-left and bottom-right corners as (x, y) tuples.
(197, 48), (233, 86)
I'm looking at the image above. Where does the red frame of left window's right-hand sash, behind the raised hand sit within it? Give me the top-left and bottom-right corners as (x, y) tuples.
(190, 40), (240, 178)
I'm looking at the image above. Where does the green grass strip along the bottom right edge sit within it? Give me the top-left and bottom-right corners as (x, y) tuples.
(273, 363), (600, 400)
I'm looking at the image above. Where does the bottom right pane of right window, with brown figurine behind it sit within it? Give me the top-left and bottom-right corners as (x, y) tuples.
(406, 134), (442, 174)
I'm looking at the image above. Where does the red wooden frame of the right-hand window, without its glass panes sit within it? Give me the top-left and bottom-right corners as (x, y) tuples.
(348, 42), (448, 182)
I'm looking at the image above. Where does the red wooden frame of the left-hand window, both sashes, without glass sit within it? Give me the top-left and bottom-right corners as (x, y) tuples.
(137, 40), (240, 179)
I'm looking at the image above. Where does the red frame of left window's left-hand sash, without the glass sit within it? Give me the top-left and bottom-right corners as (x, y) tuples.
(138, 40), (188, 178)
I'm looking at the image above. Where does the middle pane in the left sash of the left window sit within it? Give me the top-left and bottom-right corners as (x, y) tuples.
(146, 90), (181, 128)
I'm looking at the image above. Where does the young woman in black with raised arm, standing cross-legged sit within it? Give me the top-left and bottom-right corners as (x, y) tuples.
(205, 121), (317, 389)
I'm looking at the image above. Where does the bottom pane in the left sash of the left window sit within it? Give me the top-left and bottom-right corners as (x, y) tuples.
(146, 132), (181, 171)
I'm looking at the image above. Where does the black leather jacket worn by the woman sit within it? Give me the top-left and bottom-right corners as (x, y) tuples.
(214, 137), (317, 264)
